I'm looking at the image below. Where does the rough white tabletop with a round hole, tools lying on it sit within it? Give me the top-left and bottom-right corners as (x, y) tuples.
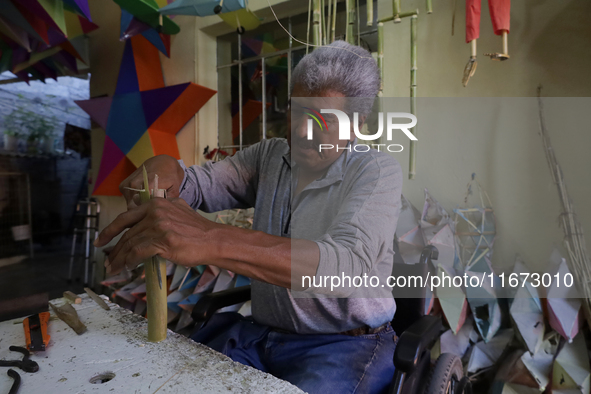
(0, 294), (303, 394)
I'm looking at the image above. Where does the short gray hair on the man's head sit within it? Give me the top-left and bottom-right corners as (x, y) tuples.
(290, 41), (380, 115)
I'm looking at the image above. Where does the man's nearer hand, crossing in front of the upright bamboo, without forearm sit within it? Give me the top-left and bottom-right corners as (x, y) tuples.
(95, 198), (219, 274)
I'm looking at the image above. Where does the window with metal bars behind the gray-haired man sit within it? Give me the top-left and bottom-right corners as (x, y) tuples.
(217, 2), (377, 155)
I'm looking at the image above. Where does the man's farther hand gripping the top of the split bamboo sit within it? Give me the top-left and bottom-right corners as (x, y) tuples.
(119, 155), (185, 209)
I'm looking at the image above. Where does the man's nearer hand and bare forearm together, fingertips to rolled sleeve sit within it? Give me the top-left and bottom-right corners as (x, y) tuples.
(94, 193), (320, 290)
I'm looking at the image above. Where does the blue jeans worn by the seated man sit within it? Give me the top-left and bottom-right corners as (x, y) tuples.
(191, 312), (398, 394)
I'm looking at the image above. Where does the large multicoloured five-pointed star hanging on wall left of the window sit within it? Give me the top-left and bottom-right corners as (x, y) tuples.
(76, 35), (216, 196)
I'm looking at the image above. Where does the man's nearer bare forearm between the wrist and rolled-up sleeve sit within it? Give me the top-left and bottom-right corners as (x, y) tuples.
(206, 225), (320, 290)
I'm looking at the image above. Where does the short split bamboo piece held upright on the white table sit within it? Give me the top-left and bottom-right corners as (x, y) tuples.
(140, 167), (168, 342)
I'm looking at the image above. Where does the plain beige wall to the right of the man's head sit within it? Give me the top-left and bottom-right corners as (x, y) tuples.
(379, 0), (591, 270)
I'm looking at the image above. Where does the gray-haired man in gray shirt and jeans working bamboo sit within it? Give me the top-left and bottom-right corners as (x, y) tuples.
(97, 41), (402, 393)
